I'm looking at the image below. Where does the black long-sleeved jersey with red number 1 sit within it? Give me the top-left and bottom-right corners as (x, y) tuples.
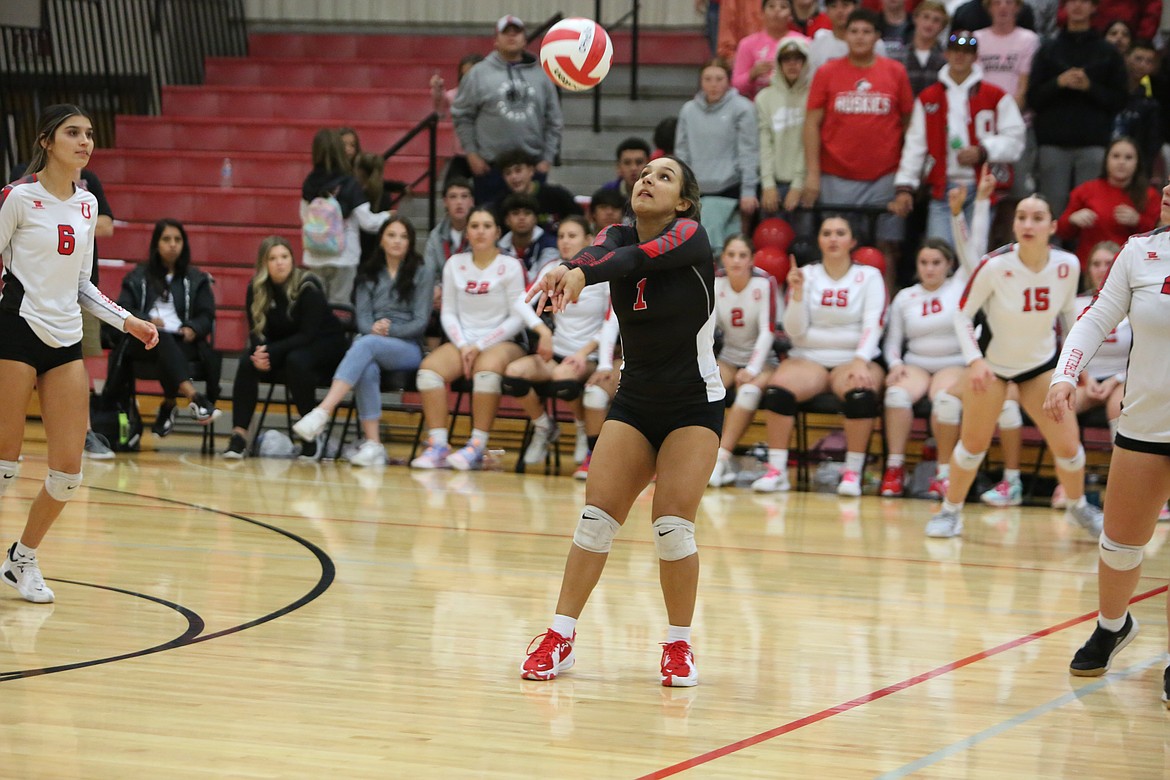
(565, 218), (724, 403)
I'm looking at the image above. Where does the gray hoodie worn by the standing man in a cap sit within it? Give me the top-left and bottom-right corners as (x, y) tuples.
(450, 51), (564, 163)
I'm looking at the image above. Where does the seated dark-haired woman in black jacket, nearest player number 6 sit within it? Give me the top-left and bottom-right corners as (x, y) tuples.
(102, 219), (222, 436)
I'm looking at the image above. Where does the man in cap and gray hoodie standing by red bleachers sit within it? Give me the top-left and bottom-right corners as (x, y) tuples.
(450, 14), (564, 203)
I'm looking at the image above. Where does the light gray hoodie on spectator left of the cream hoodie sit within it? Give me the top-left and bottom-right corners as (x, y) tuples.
(674, 87), (759, 198)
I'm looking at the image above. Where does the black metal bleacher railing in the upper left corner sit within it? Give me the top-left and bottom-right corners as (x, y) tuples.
(0, 0), (248, 181)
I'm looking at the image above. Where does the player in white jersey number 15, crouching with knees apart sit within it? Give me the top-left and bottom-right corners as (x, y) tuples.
(927, 195), (1101, 538)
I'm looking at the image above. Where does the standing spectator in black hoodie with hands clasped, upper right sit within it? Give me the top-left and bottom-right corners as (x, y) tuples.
(1027, 0), (1127, 214)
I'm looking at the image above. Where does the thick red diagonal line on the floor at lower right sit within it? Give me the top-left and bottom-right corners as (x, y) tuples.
(639, 585), (1170, 780)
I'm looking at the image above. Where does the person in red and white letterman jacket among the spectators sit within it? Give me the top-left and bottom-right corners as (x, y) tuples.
(892, 30), (1025, 243)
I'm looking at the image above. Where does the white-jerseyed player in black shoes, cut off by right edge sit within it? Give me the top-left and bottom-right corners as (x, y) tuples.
(1044, 186), (1170, 707)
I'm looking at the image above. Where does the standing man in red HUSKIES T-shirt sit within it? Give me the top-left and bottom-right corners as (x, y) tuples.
(801, 8), (914, 287)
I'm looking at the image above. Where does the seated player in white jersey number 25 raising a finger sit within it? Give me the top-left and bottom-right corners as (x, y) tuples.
(751, 216), (886, 496)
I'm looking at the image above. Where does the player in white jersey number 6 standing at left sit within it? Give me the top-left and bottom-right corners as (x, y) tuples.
(0, 105), (158, 602)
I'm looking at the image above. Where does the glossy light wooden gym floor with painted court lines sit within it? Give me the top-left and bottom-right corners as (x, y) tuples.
(0, 423), (1170, 780)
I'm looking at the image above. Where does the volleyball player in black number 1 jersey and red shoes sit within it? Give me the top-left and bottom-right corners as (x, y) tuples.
(521, 157), (724, 686)
